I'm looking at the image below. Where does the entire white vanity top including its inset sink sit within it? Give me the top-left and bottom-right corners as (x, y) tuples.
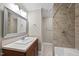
(2, 37), (37, 52)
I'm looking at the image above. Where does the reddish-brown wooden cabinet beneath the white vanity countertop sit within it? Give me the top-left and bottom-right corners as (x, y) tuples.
(3, 39), (38, 56)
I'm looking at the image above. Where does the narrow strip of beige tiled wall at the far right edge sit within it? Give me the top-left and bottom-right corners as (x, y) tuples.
(75, 3), (79, 49)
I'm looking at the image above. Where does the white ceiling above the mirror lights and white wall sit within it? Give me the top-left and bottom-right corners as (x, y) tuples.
(18, 3), (53, 11)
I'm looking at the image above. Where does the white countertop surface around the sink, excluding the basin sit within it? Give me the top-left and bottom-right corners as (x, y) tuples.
(2, 37), (37, 52)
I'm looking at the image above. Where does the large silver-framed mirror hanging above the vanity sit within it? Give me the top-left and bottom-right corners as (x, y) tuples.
(3, 7), (28, 38)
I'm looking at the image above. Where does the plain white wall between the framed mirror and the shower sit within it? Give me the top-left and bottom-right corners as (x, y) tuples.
(28, 9), (42, 49)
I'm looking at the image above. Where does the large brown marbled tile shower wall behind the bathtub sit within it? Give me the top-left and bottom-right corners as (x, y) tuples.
(53, 3), (75, 48)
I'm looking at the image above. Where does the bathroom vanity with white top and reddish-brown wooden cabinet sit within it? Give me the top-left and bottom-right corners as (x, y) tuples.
(2, 38), (38, 56)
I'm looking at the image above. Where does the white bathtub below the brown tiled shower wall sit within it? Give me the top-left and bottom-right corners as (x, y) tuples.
(54, 47), (79, 56)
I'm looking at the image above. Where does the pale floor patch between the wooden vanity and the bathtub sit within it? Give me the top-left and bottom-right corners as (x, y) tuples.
(39, 43), (53, 56)
